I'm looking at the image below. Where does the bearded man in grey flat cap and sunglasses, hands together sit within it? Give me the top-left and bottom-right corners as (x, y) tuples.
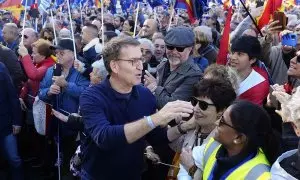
(145, 27), (202, 109)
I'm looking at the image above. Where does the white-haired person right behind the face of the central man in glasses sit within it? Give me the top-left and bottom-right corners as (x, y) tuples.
(139, 38), (159, 78)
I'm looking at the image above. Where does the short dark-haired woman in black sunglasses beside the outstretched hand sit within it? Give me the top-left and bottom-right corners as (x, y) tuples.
(169, 79), (236, 179)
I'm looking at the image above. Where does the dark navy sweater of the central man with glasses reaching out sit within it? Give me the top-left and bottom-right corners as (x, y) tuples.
(80, 79), (169, 180)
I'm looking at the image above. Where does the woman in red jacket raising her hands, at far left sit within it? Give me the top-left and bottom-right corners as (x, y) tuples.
(18, 39), (55, 166)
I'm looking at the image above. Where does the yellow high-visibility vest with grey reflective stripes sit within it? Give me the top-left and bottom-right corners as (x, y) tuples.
(203, 138), (271, 180)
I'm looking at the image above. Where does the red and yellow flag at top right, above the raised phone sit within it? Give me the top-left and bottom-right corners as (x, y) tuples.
(257, 0), (284, 29)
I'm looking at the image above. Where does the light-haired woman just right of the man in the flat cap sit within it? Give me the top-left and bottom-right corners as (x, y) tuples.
(194, 26), (218, 65)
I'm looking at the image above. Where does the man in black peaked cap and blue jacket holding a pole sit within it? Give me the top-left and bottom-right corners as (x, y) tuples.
(39, 39), (89, 176)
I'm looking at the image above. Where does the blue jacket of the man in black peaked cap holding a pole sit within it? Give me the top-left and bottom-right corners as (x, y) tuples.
(39, 67), (89, 135)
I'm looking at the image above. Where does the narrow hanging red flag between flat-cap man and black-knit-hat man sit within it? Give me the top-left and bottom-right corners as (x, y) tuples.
(217, 6), (232, 65)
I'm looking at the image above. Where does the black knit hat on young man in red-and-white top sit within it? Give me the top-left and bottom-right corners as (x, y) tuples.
(231, 36), (261, 58)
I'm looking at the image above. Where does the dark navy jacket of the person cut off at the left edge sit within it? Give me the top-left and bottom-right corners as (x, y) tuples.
(0, 62), (21, 137)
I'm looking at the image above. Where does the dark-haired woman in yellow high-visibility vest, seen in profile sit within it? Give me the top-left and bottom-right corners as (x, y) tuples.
(180, 101), (280, 180)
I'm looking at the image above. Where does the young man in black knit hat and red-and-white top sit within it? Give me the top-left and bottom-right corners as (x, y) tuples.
(229, 36), (269, 105)
